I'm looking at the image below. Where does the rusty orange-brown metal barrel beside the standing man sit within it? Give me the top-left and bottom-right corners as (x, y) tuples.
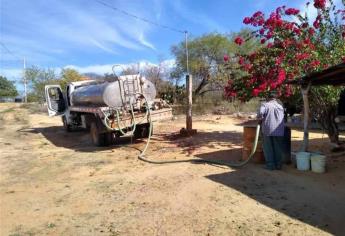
(242, 125), (265, 163)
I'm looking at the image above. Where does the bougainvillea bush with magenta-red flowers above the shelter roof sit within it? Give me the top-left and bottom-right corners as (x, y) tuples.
(225, 0), (345, 144)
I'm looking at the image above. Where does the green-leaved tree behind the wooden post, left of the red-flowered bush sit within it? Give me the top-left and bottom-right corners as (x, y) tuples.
(171, 30), (258, 96)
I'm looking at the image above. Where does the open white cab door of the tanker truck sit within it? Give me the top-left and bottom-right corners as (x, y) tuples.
(45, 85), (66, 116)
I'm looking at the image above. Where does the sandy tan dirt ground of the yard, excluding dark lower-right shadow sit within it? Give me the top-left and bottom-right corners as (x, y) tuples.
(0, 104), (345, 235)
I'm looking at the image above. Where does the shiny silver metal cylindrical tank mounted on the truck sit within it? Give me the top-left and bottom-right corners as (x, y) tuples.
(70, 75), (156, 108)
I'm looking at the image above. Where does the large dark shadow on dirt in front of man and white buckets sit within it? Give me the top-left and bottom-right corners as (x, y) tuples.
(206, 163), (345, 235)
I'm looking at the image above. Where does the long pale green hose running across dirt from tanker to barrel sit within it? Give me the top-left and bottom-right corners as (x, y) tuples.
(138, 100), (260, 167)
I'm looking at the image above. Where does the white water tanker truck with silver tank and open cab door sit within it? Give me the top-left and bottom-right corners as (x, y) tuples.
(45, 74), (172, 146)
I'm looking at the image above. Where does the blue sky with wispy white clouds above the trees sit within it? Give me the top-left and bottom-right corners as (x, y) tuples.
(0, 0), (326, 91)
